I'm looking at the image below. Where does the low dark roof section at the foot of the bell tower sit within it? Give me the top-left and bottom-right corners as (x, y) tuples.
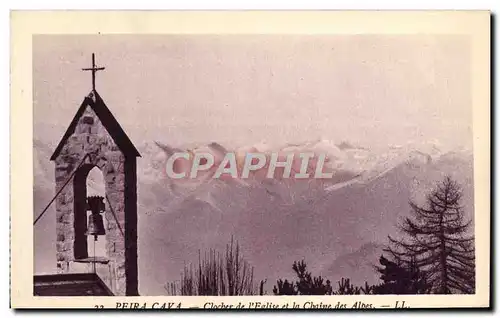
(33, 273), (114, 296)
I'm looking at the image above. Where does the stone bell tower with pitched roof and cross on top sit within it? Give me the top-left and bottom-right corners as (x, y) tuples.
(50, 55), (140, 296)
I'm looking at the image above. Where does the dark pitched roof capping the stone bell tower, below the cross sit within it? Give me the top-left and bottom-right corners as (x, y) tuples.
(50, 90), (141, 160)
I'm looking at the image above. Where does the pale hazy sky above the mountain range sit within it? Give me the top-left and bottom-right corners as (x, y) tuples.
(33, 35), (472, 151)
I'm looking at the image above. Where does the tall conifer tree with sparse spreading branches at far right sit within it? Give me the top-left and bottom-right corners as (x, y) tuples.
(386, 177), (475, 294)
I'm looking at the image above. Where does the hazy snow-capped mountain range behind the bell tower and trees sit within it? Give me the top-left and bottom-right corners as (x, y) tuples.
(34, 139), (473, 295)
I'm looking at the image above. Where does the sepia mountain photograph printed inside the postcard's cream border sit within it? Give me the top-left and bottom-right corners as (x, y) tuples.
(9, 11), (490, 309)
